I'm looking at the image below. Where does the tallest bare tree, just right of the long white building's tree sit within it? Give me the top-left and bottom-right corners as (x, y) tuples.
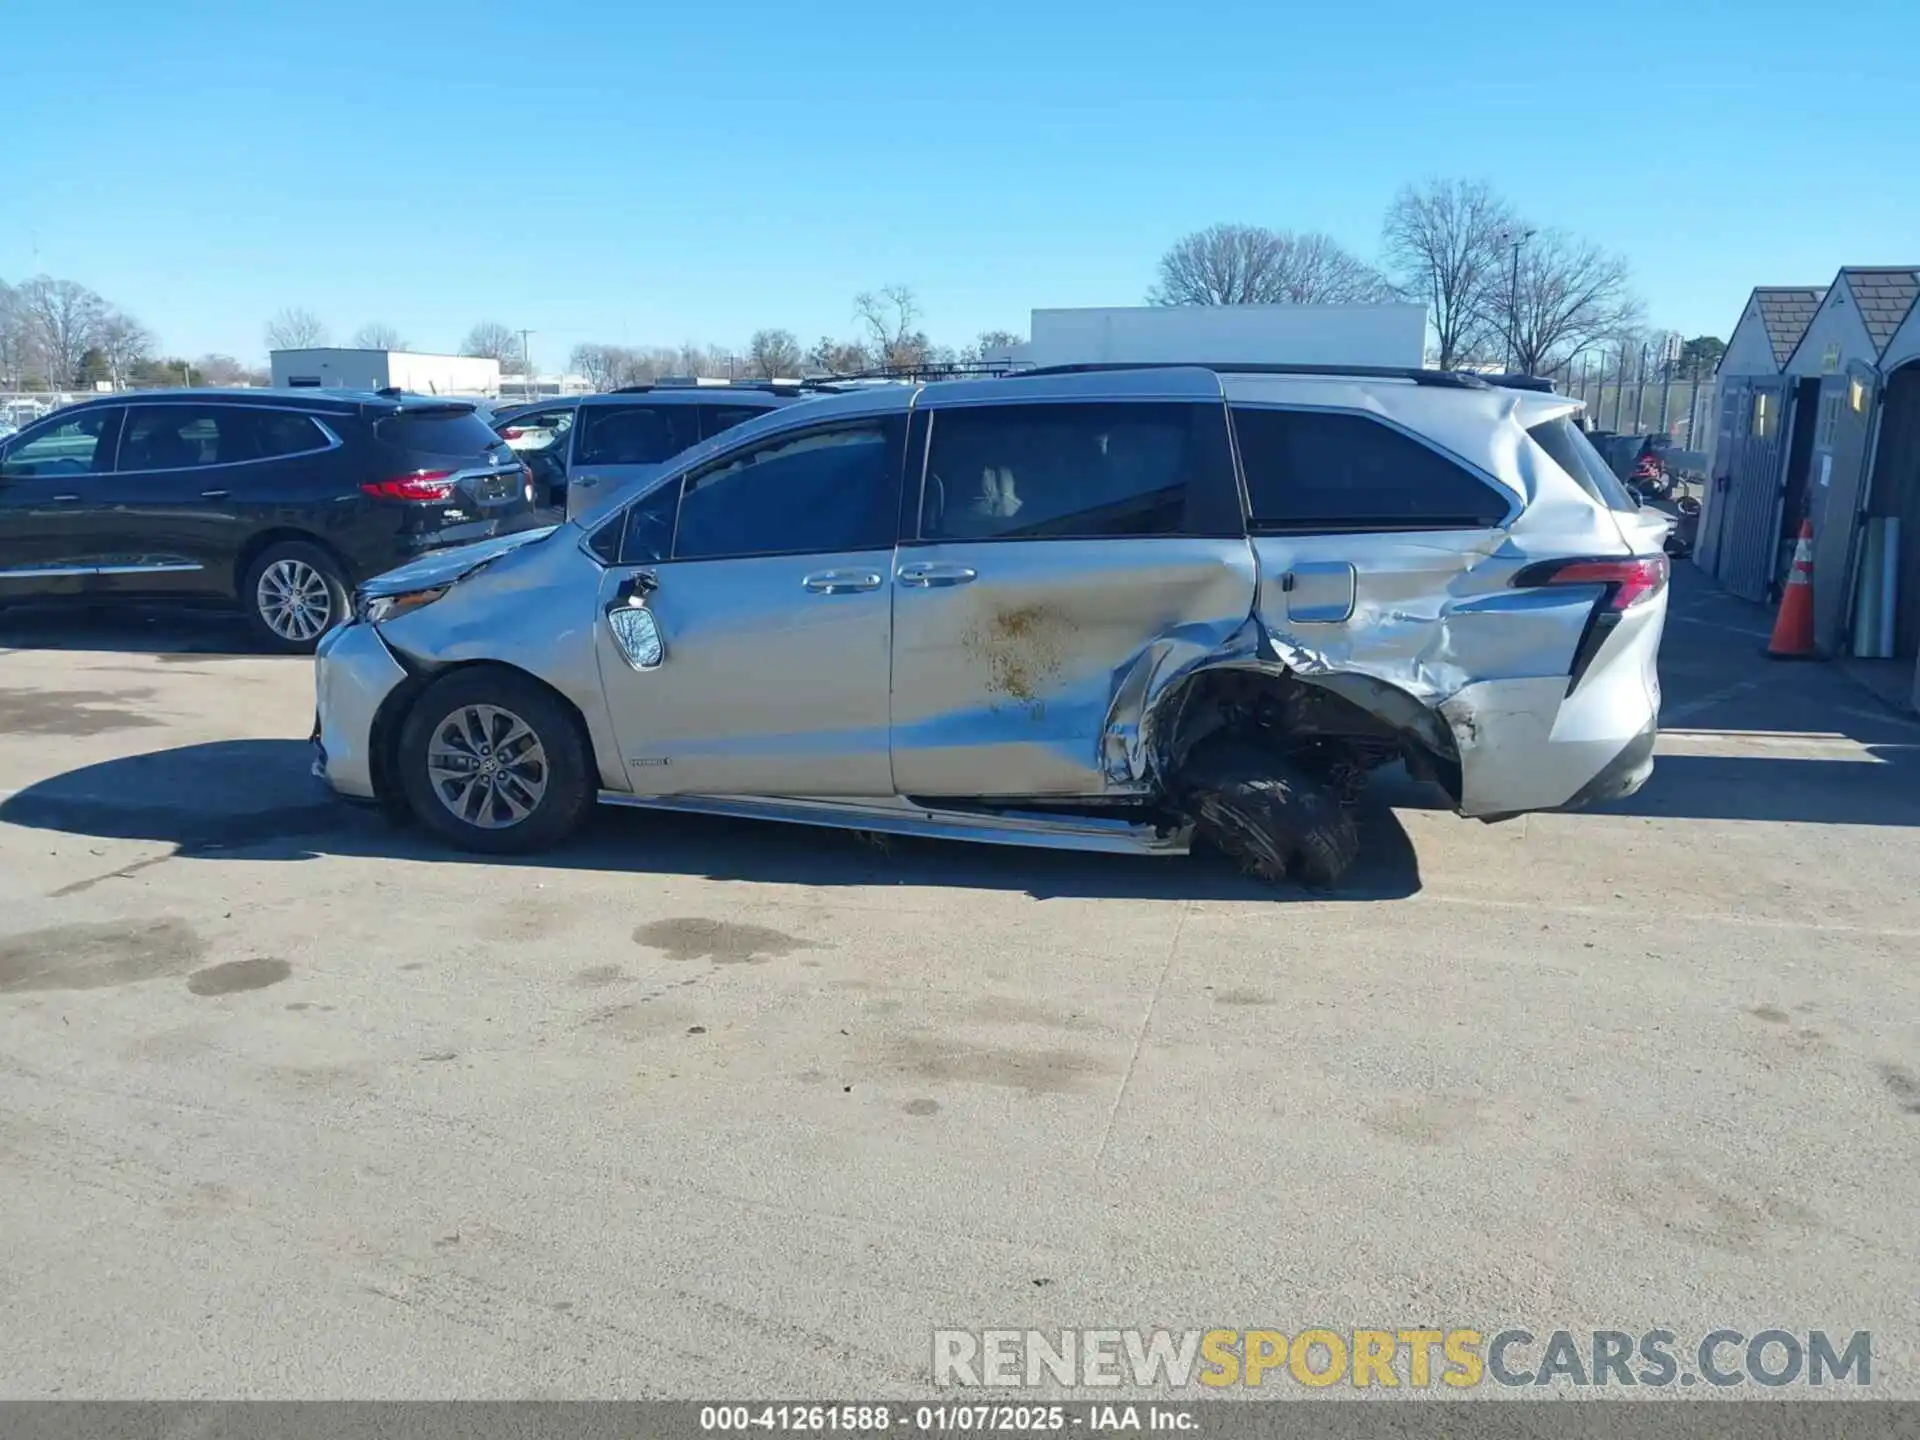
(1382, 180), (1517, 371)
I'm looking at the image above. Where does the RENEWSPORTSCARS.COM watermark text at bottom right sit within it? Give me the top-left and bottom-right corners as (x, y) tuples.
(933, 1327), (1874, 1394)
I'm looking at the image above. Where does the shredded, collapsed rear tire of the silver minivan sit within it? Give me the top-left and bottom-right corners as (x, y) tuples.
(1181, 737), (1359, 887)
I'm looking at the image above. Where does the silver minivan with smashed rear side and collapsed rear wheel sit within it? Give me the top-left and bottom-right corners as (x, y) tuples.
(315, 365), (1667, 883)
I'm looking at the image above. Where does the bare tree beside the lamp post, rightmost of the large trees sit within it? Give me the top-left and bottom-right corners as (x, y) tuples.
(1498, 230), (1640, 374)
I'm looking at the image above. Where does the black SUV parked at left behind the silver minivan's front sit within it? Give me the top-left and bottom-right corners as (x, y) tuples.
(0, 390), (538, 653)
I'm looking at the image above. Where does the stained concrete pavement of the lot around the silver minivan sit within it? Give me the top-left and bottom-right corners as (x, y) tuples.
(0, 576), (1920, 1396)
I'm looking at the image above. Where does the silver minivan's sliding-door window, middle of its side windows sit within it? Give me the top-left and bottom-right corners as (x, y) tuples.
(920, 403), (1238, 540)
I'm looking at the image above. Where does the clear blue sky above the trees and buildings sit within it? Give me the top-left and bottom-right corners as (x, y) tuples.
(0, 0), (1920, 369)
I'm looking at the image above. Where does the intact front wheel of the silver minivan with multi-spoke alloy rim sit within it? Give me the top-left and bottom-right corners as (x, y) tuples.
(399, 666), (593, 854)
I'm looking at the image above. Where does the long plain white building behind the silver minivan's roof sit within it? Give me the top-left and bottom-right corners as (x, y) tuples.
(987, 305), (1427, 367)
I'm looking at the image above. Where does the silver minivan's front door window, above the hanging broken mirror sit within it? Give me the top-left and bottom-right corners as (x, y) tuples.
(674, 419), (906, 561)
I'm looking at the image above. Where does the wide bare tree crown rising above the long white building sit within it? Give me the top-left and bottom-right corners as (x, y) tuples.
(1146, 225), (1390, 305)
